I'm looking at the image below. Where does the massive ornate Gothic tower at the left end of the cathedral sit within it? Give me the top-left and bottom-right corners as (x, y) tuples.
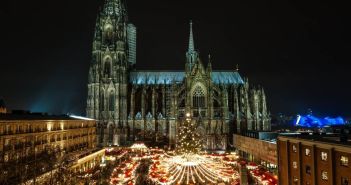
(86, 0), (136, 146)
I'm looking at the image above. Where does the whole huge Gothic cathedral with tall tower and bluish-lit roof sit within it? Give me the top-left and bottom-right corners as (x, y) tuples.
(86, 0), (270, 150)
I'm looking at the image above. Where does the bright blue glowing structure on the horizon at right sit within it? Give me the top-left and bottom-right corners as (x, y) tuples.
(295, 114), (345, 128)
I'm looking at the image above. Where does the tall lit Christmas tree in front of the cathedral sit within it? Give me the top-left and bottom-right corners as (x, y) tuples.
(176, 113), (201, 154)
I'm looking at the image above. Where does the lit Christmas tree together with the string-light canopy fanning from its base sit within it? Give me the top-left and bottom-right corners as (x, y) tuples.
(149, 113), (239, 185)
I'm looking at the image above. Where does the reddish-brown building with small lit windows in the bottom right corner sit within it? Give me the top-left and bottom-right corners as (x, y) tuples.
(277, 136), (351, 185)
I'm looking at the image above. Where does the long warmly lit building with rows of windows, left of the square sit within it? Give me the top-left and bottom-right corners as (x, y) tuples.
(0, 114), (96, 184)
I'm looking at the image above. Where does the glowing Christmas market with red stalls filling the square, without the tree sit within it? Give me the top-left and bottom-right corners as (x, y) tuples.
(107, 147), (278, 185)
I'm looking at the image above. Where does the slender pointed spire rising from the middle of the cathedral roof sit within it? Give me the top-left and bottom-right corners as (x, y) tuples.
(185, 21), (199, 73)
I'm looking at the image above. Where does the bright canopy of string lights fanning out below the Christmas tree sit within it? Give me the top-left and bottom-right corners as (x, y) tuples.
(149, 154), (239, 185)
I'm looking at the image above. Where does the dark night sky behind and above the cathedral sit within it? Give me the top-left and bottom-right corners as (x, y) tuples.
(0, 0), (351, 116)
